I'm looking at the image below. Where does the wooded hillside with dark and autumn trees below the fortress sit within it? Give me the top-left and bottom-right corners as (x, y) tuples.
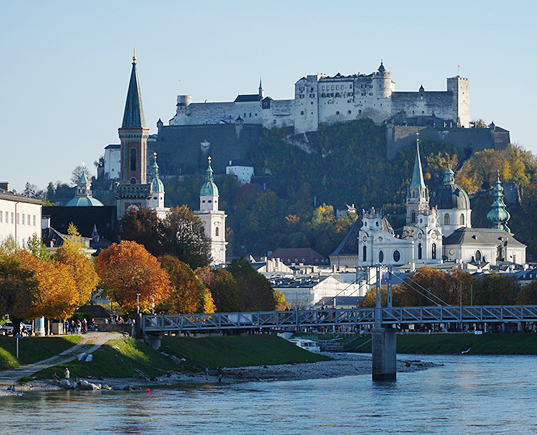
(157, 121), (537, 258)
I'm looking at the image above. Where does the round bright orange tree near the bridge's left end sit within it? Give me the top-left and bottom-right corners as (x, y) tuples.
(95, 240), (170, 313)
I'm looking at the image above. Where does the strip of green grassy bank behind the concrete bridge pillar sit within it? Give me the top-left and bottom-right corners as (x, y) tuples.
(345, 333), (537, 355)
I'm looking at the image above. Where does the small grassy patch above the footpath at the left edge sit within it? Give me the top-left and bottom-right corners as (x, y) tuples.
(0, 335), (82, 370)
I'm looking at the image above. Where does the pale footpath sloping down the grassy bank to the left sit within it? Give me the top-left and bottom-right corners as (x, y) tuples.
(0, 332), (121, 388)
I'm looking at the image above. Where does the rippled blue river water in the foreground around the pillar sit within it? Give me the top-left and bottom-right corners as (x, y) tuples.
(0, 355), (537, 435)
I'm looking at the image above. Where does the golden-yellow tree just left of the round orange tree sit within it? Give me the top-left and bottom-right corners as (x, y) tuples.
(54, 222), (99, 306)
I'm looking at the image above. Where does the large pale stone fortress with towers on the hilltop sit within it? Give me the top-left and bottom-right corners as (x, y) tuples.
(169, 63), (470, 133)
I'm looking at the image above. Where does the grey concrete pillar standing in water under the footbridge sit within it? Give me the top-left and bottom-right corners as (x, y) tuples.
(372, 326), (397, 381)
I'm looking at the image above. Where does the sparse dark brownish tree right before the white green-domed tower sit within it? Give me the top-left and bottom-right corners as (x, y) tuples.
(164, 205), (211, 269)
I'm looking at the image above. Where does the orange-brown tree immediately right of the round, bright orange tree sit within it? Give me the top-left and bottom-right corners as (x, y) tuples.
(157, 255), (216, 314)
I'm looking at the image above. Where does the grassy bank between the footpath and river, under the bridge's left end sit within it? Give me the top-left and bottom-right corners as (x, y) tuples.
(19, 335), (329, 380)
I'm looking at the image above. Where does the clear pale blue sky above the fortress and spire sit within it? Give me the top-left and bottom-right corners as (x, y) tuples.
(0, 0), (537, 192)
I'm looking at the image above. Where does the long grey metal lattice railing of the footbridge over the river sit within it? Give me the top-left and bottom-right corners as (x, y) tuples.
(142, 305), (537, 333)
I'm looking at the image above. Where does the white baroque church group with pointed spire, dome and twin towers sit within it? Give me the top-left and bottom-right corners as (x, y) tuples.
(330, 141), (526, 268)
